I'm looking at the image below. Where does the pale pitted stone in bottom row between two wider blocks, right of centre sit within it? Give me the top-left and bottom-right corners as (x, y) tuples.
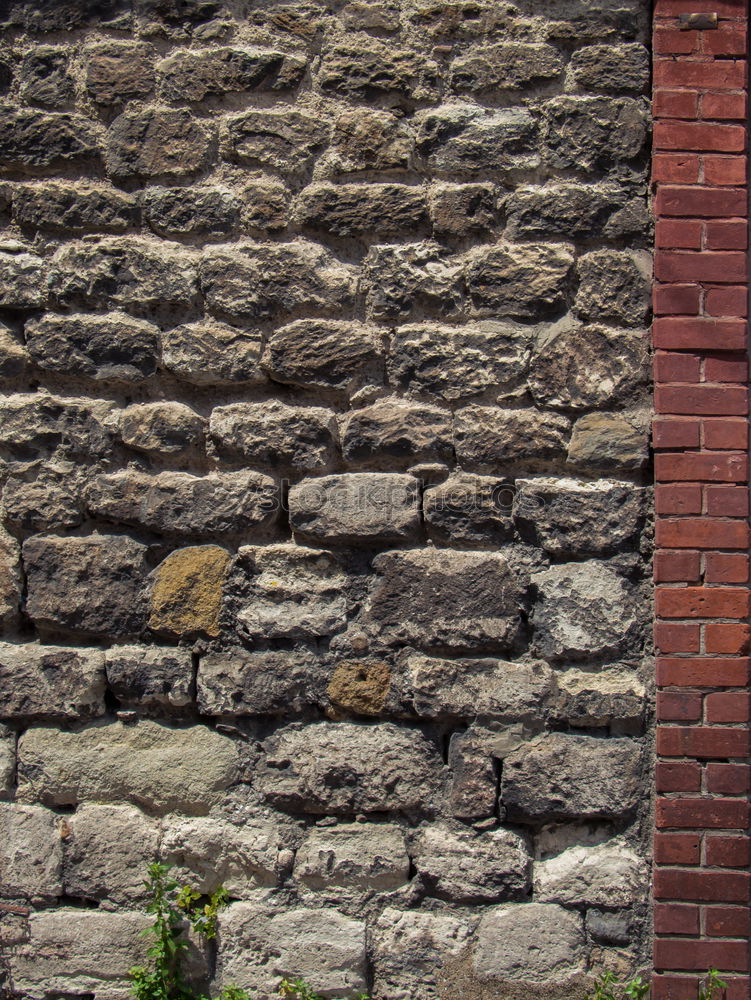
(372, 907), (470, 1000)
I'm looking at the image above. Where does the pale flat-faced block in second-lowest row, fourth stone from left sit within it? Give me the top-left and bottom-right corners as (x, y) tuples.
(294, 823), (409, 895)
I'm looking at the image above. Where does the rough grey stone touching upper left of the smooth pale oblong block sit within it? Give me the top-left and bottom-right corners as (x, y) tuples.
(209, 400), (336, 471)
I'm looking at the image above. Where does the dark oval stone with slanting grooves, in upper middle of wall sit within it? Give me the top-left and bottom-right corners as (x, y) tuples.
(262, 319), (383, 393)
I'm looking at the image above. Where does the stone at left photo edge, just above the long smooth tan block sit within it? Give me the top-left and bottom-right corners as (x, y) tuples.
(0, 642), (106, 721)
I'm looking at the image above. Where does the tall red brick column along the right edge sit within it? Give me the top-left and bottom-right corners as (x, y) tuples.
(653, 0), (751, 1000)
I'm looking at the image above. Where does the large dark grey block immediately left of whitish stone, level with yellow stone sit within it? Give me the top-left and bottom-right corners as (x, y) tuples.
(364, 549), (522, 650)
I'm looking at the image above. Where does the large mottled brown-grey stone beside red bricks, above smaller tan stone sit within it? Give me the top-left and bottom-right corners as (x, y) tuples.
(529, 320), (649, 410)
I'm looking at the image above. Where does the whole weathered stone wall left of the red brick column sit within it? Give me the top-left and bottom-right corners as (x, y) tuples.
(0, 0), (651, 1000)
